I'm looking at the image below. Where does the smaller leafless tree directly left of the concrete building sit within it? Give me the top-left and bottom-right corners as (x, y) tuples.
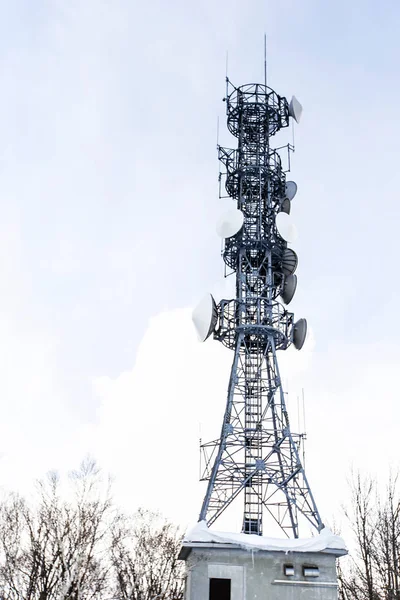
(112, 509), (183, 600)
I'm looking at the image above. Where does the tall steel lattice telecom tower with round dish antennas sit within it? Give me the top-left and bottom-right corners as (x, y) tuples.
(193, 79), (323, 537)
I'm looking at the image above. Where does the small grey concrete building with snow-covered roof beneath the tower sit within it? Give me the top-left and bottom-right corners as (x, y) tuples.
(179, 531), (347, 600)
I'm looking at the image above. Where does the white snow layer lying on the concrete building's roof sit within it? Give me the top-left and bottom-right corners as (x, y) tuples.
(183, 521), (347, 553)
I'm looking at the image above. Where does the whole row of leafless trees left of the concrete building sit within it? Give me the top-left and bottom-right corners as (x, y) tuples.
(0, 460), (183, 600)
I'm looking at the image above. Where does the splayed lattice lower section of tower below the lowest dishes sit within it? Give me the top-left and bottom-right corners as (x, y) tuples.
(200, 333), (322, 538)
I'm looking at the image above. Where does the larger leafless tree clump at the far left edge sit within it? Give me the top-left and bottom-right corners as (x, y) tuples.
(0, 461), (114, 600)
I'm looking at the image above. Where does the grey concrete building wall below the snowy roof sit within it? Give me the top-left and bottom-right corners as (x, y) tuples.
(186, 548), (337, 600)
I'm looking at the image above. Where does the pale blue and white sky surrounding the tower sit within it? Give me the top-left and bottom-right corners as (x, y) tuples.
(0, 0), (400, 540)
